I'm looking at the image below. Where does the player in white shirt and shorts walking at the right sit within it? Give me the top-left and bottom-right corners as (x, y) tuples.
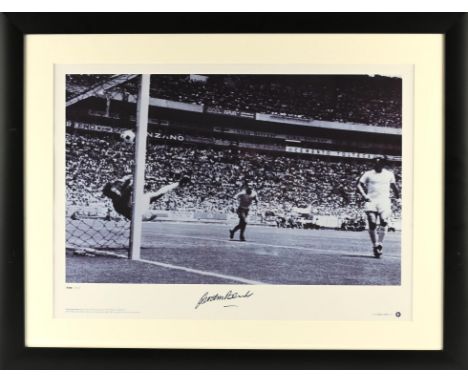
(357, 156), (400, 258)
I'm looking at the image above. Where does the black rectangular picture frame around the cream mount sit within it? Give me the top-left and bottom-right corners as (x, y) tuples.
(0, 13), (468, 369)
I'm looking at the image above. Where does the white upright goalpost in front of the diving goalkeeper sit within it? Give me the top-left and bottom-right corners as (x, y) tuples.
(129, 74), (150, 260)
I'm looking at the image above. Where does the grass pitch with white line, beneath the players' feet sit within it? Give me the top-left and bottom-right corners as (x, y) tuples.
(66, 222), (401, 285)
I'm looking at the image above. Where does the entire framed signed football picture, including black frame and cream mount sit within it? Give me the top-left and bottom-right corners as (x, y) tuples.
(2, 14), (466, 368)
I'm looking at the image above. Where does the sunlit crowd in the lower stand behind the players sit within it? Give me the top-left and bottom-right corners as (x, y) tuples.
(66, 133), (401, 217)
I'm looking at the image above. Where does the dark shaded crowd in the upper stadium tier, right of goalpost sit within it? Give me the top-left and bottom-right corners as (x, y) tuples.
(151, 75), (401, 128)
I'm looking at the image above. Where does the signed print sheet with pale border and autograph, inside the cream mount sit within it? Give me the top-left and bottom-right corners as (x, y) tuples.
(54, 68), (413, 321)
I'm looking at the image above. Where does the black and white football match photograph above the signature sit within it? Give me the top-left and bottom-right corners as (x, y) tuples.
(64, 73), (403, 286)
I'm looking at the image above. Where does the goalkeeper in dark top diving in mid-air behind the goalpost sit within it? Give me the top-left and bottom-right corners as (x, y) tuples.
(102, 175), (190, 221)
